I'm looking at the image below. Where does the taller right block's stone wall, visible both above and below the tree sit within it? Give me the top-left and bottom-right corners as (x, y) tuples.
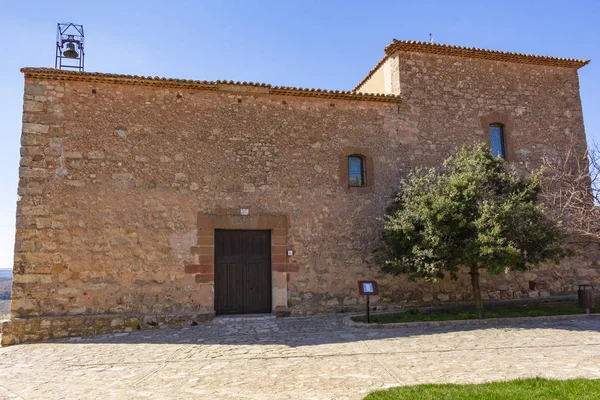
(368, 51), (600, 301)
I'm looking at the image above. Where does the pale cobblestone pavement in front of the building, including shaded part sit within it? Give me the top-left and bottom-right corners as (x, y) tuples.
(0, 315), (600, 399)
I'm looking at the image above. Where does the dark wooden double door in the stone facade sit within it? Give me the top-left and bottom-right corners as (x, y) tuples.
(215, 230), (271, 314)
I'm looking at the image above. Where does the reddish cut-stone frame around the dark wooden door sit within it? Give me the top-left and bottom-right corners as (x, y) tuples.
(184, 213), (298, 312)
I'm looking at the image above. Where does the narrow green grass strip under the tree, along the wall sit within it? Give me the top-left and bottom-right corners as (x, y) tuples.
(352, 301), (597, 324)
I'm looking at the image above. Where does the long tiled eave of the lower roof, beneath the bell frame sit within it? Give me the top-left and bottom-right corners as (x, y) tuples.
(21, 68), (401, 103)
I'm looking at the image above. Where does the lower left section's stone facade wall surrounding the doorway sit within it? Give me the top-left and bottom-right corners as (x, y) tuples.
(11, 79), (404, 332)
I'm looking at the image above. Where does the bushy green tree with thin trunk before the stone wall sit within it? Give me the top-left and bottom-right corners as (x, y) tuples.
(376, 144), (569, 318)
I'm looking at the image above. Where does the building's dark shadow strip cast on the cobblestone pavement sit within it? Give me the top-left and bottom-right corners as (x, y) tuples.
(5, 314), (600, 347)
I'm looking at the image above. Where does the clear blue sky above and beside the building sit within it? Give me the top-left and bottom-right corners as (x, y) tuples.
(0, 0), (600, 268)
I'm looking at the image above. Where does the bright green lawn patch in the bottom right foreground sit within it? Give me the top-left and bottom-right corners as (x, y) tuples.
(365, 378), (600, 400)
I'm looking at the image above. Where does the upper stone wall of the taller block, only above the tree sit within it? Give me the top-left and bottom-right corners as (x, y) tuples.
(389, 51), (585, 169)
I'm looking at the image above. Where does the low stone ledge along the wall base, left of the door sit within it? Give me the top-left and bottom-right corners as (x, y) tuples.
(0, 313), (215, 346)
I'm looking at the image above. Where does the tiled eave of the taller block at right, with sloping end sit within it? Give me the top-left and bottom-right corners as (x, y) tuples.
(354, 39), (590, 90)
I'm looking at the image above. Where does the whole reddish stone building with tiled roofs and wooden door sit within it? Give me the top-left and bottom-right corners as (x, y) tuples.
(2, 40), (600, 344)
